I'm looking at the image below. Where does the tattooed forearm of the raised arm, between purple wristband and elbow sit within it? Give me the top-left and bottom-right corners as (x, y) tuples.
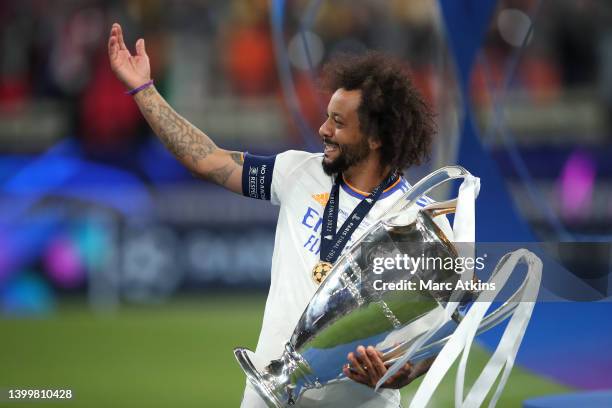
(137, 87), (217, 166)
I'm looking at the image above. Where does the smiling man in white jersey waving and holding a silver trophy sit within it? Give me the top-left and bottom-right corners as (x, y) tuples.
(108, 24), (452, 408)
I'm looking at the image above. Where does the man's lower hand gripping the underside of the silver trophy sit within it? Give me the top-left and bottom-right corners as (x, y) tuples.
(342, 346), (420, 388)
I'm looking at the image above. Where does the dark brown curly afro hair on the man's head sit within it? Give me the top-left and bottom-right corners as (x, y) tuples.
(322, 51), (436, 170)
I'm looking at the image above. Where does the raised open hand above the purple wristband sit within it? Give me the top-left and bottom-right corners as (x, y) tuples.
(108, 23), (151, 89)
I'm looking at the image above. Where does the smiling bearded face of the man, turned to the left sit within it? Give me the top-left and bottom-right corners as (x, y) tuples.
(319, 88), (372, 175)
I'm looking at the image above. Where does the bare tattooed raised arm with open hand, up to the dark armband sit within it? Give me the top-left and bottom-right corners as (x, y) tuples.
(108, 24), (243, 194)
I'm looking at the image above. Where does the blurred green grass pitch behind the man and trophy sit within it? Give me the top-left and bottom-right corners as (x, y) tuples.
(0, 294), (567, 408)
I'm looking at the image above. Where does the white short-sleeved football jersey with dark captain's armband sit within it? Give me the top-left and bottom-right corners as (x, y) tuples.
(242, 150), (452, 408)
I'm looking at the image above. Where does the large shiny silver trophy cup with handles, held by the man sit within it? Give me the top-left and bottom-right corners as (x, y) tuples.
(234, 166), (524, 408)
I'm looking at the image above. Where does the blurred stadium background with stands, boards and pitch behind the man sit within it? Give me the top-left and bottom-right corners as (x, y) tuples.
(0, 0), (612, 407)
